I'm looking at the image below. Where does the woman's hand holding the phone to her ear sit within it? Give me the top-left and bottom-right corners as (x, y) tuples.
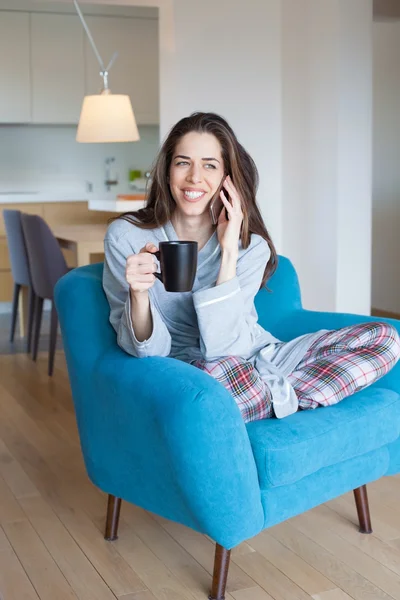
(217, 175), (243, 252)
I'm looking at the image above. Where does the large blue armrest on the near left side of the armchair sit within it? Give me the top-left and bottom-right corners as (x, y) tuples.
(70, 347), (264, 548)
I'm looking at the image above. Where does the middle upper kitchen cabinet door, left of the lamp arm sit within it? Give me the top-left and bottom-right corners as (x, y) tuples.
(31, 13), (85, 124)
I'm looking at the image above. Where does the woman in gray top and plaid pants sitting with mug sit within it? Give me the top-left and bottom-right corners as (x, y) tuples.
(103, 113), (400, 422)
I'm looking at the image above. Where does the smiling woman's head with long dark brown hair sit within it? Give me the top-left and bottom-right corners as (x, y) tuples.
(115, 112), (277, 285)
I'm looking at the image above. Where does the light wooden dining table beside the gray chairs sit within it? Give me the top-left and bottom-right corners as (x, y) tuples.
(53, 225), (107, 267)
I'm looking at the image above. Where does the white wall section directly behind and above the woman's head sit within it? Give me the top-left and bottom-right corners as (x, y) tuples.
(164, 0), (281, 246)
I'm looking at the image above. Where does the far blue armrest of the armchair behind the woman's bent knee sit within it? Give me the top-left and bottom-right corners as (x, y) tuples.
(273, 309), (400, 394)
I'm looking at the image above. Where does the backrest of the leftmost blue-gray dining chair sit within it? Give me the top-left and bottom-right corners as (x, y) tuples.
(3, 209), (31, 285)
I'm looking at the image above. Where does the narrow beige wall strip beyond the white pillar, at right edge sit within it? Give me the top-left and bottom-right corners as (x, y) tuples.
(372, 21), (400, 314)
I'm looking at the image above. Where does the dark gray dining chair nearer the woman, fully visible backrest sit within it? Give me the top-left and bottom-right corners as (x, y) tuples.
(21, 214), (69, 376)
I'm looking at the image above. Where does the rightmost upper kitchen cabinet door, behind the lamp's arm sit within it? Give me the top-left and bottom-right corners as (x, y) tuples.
(85, 16), (159, 125)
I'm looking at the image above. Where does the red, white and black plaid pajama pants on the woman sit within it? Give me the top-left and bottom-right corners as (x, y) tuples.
(193, 322), (400, 422)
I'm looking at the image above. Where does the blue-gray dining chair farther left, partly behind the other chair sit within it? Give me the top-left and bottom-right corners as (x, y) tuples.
(3, 209), (35, 352)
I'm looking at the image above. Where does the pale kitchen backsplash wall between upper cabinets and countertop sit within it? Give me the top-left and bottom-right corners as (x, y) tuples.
(0, 125), (159, 192)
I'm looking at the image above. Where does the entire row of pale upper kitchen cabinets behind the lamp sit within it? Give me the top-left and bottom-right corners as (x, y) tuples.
(0, 10), (159, 125)
